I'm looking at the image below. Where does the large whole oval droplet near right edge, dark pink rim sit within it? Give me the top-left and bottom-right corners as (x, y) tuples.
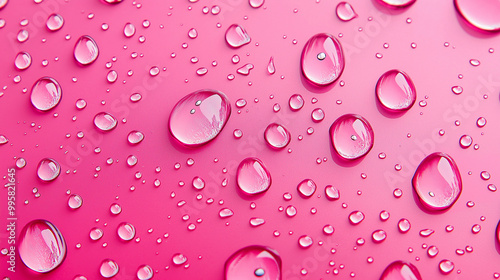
(412, 153), (462, 210)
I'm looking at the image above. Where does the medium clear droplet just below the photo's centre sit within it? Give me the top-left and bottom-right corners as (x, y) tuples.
(236, 158), (271, 195)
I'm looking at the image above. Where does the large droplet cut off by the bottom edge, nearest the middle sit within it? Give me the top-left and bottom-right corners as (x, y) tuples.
(224, 246), (281, 280)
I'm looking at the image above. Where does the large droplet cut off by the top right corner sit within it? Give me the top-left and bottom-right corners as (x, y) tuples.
(454, 0), (500, 32)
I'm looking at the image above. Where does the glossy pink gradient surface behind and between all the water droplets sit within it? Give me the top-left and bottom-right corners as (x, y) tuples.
(0, 0), (500, 279)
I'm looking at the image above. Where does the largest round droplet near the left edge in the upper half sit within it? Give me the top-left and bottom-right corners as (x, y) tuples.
(31, 77), (62, 112)
